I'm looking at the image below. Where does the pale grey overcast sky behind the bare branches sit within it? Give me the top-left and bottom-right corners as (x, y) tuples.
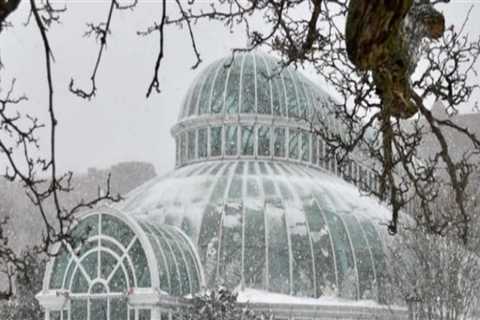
(0, 0), (480, 178)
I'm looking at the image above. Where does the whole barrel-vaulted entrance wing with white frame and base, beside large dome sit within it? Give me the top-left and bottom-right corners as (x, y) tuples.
(38, 209), (203, 320)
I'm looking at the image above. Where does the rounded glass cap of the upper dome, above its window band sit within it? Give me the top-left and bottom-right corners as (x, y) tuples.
(179, 53), (338, 120)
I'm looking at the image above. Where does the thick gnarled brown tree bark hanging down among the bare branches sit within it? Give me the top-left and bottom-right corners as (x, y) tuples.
(345, 0), (445, 119)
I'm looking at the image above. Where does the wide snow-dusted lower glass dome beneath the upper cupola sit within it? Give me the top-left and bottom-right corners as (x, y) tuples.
(121, 160), (388, 302)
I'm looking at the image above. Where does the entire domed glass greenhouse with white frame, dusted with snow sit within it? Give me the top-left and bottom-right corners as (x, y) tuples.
(38, 53), (407, 320)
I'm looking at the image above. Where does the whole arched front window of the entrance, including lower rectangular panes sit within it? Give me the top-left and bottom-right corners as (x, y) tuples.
(49, 214), (151, 320)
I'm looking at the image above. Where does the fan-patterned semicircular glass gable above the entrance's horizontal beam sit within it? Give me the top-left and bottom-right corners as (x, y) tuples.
(49, 214), (151, 294)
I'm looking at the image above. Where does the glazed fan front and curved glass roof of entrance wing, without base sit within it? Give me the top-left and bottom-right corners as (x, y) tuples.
(48, 213), (203, 296)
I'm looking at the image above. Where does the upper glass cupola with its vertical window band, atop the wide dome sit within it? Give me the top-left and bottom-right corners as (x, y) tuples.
(172, 53), (348, 174)
